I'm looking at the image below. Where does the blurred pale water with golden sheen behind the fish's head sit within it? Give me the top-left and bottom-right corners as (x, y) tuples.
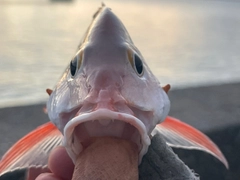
(0, 0), (240, 107)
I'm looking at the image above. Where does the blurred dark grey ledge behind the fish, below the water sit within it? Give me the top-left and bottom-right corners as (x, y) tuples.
(0, 83), (240, 180)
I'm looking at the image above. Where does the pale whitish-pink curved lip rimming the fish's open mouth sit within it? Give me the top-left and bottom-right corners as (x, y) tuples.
(63, 109), (150, 164)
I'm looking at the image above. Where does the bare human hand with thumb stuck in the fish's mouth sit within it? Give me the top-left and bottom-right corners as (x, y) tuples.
(36, 137), (138, 180)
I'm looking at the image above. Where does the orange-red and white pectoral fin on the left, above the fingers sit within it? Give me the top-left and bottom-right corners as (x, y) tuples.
(0, 122), (62, 177)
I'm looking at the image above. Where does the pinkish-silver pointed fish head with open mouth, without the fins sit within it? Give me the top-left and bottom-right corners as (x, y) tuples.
(47, 7), (170, 162)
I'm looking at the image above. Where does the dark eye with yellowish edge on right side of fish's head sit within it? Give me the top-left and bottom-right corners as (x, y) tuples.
(128, 50), (143, 76)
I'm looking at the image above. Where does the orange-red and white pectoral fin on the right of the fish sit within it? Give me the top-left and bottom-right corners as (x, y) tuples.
(155, 116), (228, 169)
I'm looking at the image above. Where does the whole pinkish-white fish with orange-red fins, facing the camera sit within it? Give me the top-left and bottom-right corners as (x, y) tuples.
(0, 5), (228, 177)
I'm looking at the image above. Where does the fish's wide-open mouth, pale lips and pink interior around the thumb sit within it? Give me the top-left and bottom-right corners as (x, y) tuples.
(63, 109), (150, 163)
